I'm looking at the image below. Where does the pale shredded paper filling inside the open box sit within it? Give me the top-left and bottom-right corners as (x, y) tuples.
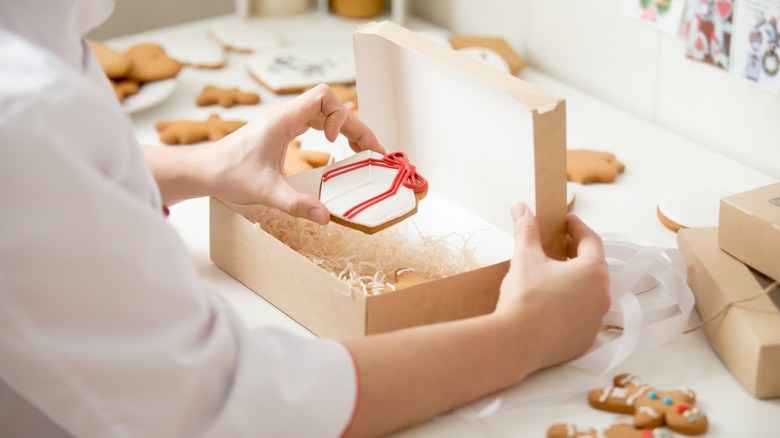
(254, 208), (480, 295)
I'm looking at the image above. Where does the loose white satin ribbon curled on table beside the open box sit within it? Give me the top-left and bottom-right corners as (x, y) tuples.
(455, 234), (695, 420)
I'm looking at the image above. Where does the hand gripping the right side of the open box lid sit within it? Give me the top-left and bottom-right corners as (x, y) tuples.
(495, 204), (610, 369)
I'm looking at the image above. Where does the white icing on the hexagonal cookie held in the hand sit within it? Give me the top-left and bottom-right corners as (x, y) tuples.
(320, 151), (417, 228)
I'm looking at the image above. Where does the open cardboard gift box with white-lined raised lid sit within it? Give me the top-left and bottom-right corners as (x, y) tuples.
(210, 22), (567, 338)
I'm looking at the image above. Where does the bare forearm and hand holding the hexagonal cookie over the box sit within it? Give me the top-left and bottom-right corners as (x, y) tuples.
(143, 85), (384, 224)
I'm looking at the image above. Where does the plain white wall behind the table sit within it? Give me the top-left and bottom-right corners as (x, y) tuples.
(408, 0), (780, 179)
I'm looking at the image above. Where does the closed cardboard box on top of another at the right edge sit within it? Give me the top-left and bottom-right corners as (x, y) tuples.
(718, 183), (780, 280)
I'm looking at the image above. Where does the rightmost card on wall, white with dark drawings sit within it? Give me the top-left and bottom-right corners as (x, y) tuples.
(733, 0), (780, 94)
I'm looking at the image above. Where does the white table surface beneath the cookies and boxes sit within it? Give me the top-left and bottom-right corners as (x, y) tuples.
(116, 14), (780, 438)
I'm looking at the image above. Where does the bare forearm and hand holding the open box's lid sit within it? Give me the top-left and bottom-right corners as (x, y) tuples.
(345, 204), (609, 436)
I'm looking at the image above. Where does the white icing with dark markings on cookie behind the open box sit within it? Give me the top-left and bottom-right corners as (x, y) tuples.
(246, 48), (355, 91)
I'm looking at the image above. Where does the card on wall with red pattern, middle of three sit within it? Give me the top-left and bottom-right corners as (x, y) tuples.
(685, 0), (734, 71)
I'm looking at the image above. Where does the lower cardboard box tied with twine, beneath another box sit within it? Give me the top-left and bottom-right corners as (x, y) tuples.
(677, 228), (780, 398)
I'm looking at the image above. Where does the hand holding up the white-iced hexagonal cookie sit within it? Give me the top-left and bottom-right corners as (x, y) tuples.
(204, 85), (385, 225)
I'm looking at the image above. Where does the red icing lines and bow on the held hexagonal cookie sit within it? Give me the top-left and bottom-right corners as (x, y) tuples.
(322, 152), (428, 219)
